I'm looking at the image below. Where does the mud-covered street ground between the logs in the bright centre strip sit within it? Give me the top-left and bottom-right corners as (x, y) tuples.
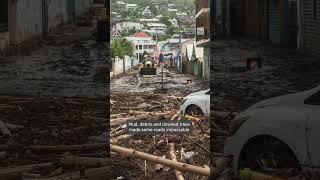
(110, 69), (210, 179)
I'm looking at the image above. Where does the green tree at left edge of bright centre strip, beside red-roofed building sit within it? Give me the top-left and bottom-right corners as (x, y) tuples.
(111, 38), (133, 59)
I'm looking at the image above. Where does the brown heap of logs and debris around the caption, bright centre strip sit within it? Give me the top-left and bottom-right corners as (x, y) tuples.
(110, 92), (210, 179)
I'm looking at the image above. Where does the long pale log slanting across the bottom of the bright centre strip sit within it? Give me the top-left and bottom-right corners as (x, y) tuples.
(110, 144), (210, 176)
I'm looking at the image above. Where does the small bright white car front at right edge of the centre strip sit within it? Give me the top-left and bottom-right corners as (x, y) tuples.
(180, 89), (210, 115)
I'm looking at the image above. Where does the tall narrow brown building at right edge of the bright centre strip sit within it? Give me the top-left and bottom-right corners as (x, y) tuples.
(193, 0), (211, 80)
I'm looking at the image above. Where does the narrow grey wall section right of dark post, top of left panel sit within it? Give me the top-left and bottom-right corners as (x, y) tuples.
(48, 0), (68, 31)
